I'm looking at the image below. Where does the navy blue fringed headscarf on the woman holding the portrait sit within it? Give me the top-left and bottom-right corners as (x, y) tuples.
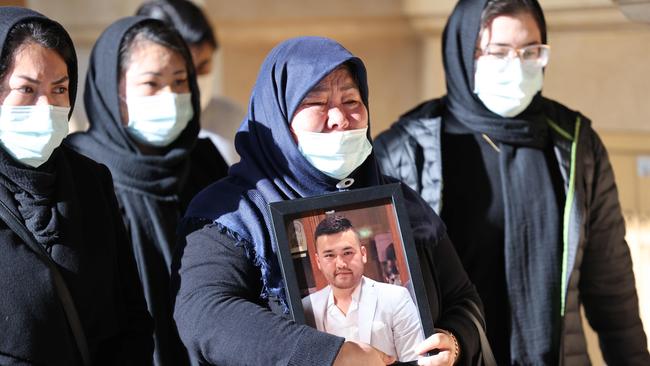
(186, 37), (444, 306)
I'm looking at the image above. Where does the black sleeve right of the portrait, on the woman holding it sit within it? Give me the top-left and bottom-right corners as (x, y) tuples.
(430, 235), (484, 365)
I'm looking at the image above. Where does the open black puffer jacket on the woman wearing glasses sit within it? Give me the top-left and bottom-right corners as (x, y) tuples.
(374, 99), (650, 365)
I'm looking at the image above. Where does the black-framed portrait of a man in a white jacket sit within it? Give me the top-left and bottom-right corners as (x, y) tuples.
(269, 183), (433, 362)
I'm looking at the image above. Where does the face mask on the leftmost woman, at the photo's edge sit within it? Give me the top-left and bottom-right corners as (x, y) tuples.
(0, 105), (70, 168)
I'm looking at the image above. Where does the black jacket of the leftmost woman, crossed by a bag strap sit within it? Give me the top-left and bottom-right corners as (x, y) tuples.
(0, 146), (153, 366)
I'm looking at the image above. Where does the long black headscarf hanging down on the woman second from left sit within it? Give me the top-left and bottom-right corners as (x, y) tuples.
(67, 16), (200, 365)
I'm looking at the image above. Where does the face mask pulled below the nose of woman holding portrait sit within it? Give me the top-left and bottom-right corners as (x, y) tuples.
(294, 127), (372, 179)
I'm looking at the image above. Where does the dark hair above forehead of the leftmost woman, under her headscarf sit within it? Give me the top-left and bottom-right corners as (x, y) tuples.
(0, 18), (77, 93)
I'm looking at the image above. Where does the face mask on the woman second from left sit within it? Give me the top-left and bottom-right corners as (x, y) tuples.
(126, 93), (194, 147)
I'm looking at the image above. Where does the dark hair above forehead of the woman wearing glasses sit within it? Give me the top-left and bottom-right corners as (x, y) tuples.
(479, 0), (546, 43)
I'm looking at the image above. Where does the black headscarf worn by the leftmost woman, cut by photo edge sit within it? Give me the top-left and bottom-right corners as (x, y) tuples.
(0, 7), (77, 256)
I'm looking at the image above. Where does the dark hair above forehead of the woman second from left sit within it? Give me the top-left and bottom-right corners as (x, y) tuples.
(118, 19), (194, 72)
